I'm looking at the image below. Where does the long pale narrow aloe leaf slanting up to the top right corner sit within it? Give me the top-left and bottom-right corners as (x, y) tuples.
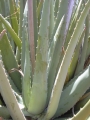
(45, 0), (90, 120)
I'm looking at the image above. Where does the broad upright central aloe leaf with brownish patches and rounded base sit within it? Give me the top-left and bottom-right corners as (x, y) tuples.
(29, 0), (51, 114)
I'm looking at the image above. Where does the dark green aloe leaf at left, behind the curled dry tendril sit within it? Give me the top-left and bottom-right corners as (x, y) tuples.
(0, 25), (21, 92)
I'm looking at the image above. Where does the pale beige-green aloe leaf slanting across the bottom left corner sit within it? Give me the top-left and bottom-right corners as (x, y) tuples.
(0, 61), (25, 120)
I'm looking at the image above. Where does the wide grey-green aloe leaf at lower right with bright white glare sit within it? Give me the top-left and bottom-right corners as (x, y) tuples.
(55, 66), (90, 117)
